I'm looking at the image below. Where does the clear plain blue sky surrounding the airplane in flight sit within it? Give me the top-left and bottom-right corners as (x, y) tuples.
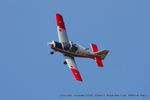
(0, 0), (150, 100)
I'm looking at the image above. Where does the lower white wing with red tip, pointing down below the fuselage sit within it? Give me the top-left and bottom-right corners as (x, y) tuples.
(64, 55), (82, 81)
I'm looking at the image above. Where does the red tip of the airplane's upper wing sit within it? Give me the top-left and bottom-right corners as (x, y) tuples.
(56, 13), (66, 30)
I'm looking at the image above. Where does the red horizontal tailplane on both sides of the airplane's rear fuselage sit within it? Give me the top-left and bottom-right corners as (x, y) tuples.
(91, 43), (103, 67)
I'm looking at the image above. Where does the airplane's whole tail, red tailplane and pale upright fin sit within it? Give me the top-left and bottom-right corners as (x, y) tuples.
(91, 43), (109, 67)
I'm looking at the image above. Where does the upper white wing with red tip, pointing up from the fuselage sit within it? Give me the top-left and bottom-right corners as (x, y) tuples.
(56, 13), (68, 42)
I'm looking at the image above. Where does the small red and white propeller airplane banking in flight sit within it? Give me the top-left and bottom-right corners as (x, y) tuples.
(48, 13), (109, 82)
